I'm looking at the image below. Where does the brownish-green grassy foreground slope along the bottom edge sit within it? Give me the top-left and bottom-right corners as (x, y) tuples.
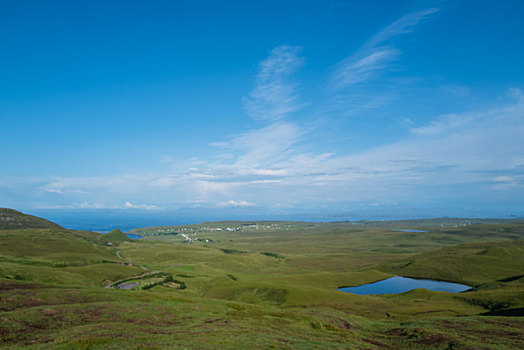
(0, 282), (524, 349)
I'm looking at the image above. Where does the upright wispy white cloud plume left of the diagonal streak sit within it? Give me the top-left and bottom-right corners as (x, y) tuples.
(206, 45), (309, 176)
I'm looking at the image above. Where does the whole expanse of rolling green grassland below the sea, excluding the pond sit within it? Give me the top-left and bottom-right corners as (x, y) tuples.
(0, 209), (524, 349)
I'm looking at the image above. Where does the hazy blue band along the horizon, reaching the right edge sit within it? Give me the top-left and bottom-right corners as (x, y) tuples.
(10, 208), (523, 232)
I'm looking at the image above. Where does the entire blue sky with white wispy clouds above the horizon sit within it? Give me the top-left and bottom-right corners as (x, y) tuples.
(0, 0), (524, 216)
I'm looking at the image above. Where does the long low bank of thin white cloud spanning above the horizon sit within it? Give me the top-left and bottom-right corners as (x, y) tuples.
(0, 90), (524, 209)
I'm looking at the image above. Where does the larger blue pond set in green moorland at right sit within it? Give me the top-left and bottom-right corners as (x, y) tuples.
(338, 276), (471, 295)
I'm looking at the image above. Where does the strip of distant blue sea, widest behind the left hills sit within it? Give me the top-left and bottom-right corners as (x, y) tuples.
(30, 210), (430, 232)
